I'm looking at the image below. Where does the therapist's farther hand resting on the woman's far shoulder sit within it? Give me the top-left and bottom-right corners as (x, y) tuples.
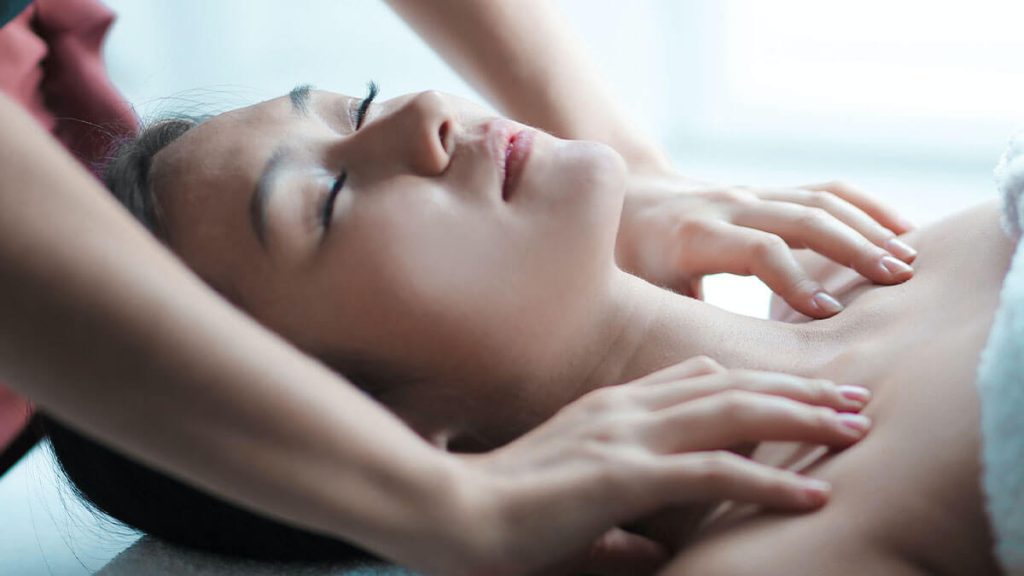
(615, 170), (916, 318)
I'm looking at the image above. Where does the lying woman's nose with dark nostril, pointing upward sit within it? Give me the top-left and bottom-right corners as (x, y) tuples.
(366, 91), (457, 176)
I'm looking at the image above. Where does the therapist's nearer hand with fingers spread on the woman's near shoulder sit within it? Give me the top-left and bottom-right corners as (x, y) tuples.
(444, 357), (867, 575)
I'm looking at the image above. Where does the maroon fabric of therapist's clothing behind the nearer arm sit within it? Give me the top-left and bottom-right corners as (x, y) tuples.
(0, 0), (138, 463)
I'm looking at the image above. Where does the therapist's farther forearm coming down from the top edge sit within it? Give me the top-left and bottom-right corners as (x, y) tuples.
(388, 0), (669, 168)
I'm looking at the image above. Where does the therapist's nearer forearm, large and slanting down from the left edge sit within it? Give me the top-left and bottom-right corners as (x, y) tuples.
(0, 96), (460, 560)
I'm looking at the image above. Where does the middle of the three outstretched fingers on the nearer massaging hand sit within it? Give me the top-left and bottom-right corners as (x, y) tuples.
(641, 390), (870, 453)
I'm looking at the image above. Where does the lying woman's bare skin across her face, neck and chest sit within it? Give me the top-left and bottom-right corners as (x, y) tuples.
(155, 81), (1011, 574)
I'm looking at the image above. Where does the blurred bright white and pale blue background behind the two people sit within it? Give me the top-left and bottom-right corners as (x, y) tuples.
(0, 0), (1024, 574)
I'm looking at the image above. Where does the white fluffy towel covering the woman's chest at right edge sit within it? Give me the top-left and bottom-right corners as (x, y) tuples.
(978, 134), (1024, 576)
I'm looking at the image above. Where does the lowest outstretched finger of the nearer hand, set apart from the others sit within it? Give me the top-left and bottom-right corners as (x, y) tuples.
(649, 450), (830, 510)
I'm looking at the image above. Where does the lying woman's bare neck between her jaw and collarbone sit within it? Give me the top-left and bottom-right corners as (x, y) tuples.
(580, 273), (845, 393)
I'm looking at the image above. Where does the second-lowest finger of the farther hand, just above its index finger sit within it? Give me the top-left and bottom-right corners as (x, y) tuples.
(733, 201), (913, 284)
